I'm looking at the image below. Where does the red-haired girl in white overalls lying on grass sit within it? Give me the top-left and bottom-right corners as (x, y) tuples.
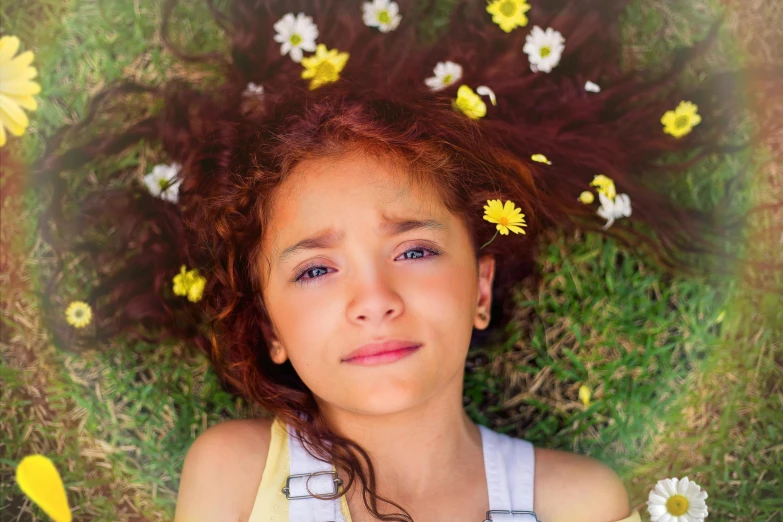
(39, 0), (772, 522)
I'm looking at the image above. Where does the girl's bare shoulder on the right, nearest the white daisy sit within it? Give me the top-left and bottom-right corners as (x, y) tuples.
(533, 447), (631, 522)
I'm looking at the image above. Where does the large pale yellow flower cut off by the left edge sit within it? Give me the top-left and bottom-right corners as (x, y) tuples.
(0, 36), (41, 147)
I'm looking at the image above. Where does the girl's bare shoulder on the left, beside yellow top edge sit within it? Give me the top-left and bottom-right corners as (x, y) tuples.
(174, 418), (272, 522)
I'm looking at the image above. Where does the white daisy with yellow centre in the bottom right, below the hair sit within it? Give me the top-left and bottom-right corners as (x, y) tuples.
(647, 477), (708, 522)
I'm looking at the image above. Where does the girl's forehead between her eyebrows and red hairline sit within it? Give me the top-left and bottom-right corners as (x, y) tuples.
(265, 150), (451, 244)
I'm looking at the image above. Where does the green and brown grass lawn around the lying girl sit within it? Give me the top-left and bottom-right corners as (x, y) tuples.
(0, 0), (783, 522)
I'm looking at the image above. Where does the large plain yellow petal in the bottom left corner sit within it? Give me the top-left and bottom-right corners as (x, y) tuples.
(16, 455), (72, 522)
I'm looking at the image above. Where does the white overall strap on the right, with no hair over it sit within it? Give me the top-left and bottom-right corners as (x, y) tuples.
(478, 424), (540, 522)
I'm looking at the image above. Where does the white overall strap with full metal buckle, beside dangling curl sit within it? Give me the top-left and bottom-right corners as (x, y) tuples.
(283, 416), (345, 522)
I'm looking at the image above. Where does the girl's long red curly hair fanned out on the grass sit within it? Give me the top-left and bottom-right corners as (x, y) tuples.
(34, 0), (783, 520)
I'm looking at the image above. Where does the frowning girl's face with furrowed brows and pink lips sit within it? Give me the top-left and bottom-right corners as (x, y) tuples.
(259, 148), (495, 415)
